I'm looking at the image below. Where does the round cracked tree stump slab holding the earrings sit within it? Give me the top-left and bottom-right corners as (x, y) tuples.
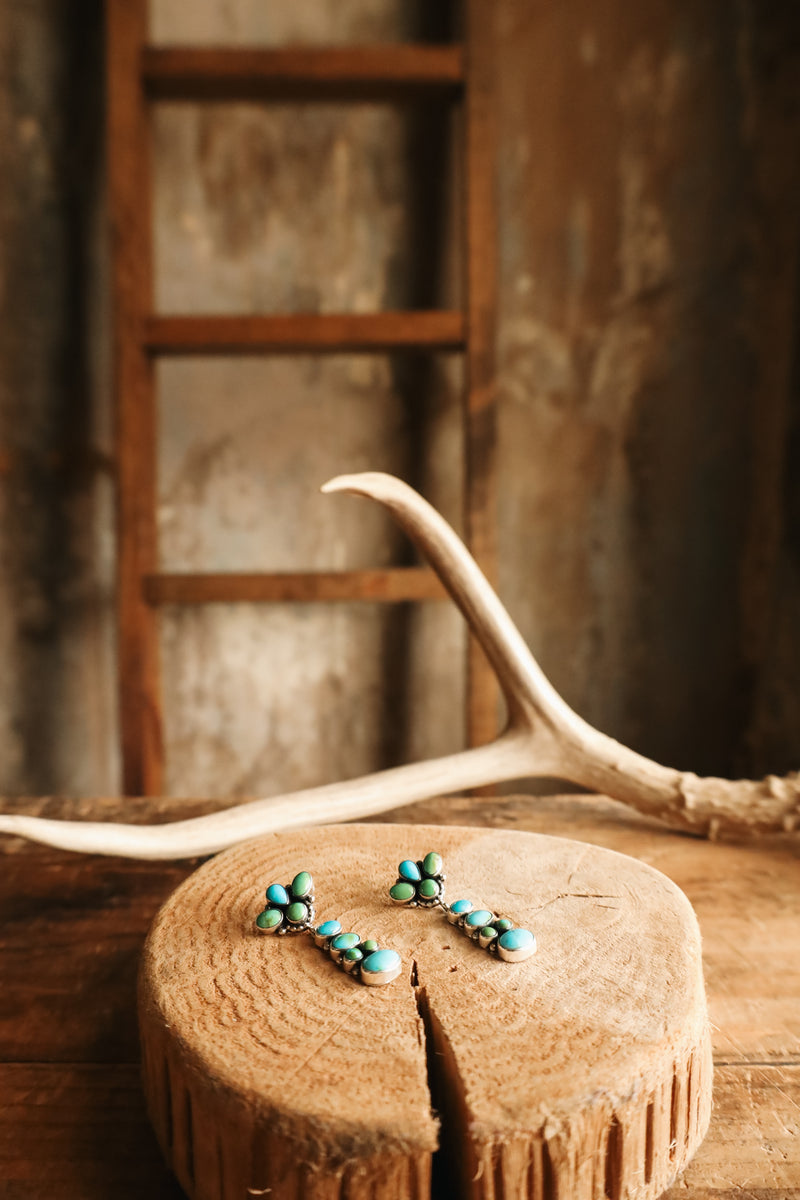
(140, 824), (711, 1200)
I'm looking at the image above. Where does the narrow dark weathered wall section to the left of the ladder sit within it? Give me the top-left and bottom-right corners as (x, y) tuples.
(0, 0), (116, 793)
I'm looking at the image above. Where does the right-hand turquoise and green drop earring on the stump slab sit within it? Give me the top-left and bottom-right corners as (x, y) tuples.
(389, 851), (536, 962)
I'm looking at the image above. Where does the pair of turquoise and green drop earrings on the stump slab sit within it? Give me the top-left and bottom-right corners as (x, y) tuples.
(255, 851), (536, 986)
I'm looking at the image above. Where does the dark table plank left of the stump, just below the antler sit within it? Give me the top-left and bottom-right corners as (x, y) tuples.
(0, 854), (191, 1060)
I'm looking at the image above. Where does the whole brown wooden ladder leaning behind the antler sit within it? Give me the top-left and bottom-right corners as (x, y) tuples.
(107, 0), (498, 794)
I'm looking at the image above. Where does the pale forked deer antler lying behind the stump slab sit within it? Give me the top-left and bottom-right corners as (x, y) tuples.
(0, 473), (800, 859)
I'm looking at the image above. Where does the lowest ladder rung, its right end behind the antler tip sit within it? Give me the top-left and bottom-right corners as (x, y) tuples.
(143, 566), (446, 605)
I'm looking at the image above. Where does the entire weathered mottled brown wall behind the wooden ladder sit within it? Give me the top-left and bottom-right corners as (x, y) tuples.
(0, 0), (800, 794)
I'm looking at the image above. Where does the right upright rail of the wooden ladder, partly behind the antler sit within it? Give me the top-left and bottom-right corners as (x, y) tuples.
(464, 0), (499, 745)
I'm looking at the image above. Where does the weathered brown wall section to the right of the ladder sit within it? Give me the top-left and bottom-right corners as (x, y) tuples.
(499, 0), (800, 773)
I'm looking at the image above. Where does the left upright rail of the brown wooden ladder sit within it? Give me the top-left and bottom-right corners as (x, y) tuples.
(106, 0), (163, 794)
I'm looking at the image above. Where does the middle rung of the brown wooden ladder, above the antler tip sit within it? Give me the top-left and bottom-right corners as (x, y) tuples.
(144, 311), (464, 354)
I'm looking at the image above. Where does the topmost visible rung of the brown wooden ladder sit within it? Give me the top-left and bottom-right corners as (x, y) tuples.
(142, 44), (464, 100)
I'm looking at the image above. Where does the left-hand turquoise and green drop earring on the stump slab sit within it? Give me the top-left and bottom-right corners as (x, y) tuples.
(255, 871), (402, 988)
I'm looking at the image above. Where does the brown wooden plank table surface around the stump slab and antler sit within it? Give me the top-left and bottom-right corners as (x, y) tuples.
(0, 796), (800, 1200)
